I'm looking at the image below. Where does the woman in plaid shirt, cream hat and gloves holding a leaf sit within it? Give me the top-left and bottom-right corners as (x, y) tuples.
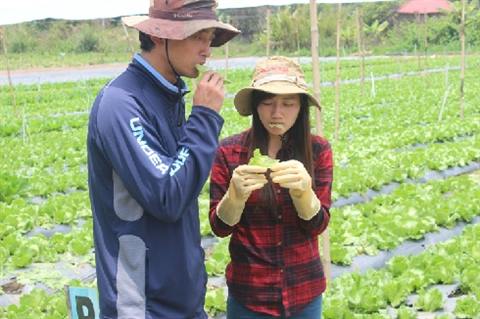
(210, 57), (333, 319)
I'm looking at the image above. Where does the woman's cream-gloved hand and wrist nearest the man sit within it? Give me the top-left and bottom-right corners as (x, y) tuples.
(217, 165), (268, 226)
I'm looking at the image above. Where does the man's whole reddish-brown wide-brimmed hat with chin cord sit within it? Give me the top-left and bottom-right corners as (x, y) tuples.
(122, 0), (240, 47)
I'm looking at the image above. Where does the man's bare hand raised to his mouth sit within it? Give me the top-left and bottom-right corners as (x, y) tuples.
(193, 71), (225, 112)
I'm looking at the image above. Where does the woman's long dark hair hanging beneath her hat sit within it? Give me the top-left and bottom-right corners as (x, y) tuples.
(248, 90), (314, 207)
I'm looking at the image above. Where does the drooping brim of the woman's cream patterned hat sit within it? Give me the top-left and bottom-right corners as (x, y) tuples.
(233, 82), (321, 116)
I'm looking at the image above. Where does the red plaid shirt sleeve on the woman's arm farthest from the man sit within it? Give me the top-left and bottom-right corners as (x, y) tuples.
(297, 141), (333, 236)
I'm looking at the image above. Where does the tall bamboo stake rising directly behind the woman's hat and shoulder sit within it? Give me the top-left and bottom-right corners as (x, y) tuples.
(310, 0), (323, 136)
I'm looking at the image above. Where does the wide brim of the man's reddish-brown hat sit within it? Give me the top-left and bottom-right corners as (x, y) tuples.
(122, 16), (240, 47)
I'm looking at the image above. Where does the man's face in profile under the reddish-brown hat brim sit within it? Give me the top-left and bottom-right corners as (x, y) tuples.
(168, 28), (215, 78)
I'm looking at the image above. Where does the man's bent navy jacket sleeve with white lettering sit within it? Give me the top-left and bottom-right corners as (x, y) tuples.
(97, 88), (223, 222)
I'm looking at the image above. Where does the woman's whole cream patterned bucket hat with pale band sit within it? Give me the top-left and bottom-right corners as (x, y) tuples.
(233, 56), (321, 116)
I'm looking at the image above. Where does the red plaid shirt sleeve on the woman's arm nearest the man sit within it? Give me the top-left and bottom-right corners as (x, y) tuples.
(210, 147), (234, 237)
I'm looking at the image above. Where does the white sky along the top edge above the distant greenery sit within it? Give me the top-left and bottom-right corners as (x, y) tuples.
(0, 0), (392, 26)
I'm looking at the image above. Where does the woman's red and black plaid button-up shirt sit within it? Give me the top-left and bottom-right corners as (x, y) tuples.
(210, 131), (333, 316)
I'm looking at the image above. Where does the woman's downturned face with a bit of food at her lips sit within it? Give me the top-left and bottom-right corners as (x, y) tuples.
(257, 94), (300, 136)
